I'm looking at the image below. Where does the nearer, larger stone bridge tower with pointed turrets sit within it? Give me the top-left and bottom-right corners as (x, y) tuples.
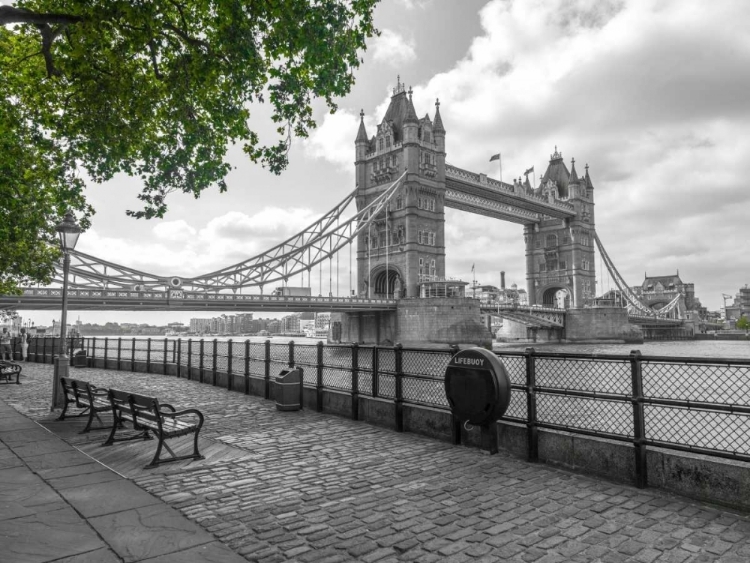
(354, 77), (445, 298)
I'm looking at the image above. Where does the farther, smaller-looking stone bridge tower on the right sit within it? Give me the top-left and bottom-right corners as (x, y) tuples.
(524, 147), (596, 309)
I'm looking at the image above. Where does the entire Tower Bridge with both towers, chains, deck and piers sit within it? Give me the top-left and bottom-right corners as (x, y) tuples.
(0, 80), (692, 343)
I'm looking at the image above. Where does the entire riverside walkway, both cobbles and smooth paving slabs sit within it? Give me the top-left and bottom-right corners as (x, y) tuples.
(0, 364), (750, 563)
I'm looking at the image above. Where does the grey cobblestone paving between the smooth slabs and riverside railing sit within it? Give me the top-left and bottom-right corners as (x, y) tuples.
(5, 364), (750, 563)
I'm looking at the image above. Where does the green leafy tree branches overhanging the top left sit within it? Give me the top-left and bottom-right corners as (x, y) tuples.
(0, 0), (378, 292)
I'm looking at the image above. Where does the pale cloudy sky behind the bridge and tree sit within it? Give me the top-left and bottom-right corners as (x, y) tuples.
(17, 0), (750, 324)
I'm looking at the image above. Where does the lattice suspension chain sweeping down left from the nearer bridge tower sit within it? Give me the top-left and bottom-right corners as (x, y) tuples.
(54, 173), (406, 292)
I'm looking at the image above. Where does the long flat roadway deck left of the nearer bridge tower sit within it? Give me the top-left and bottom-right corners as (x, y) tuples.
(0, 287), (396, 312)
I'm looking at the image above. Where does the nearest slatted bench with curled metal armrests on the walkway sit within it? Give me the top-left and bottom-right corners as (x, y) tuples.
(102, 389), (204, 469)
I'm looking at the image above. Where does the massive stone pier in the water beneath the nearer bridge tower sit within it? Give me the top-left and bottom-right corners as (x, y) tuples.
(331, 298), (492, 347)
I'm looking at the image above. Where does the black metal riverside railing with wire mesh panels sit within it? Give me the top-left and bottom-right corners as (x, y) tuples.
(23, 338), (750, 485)
